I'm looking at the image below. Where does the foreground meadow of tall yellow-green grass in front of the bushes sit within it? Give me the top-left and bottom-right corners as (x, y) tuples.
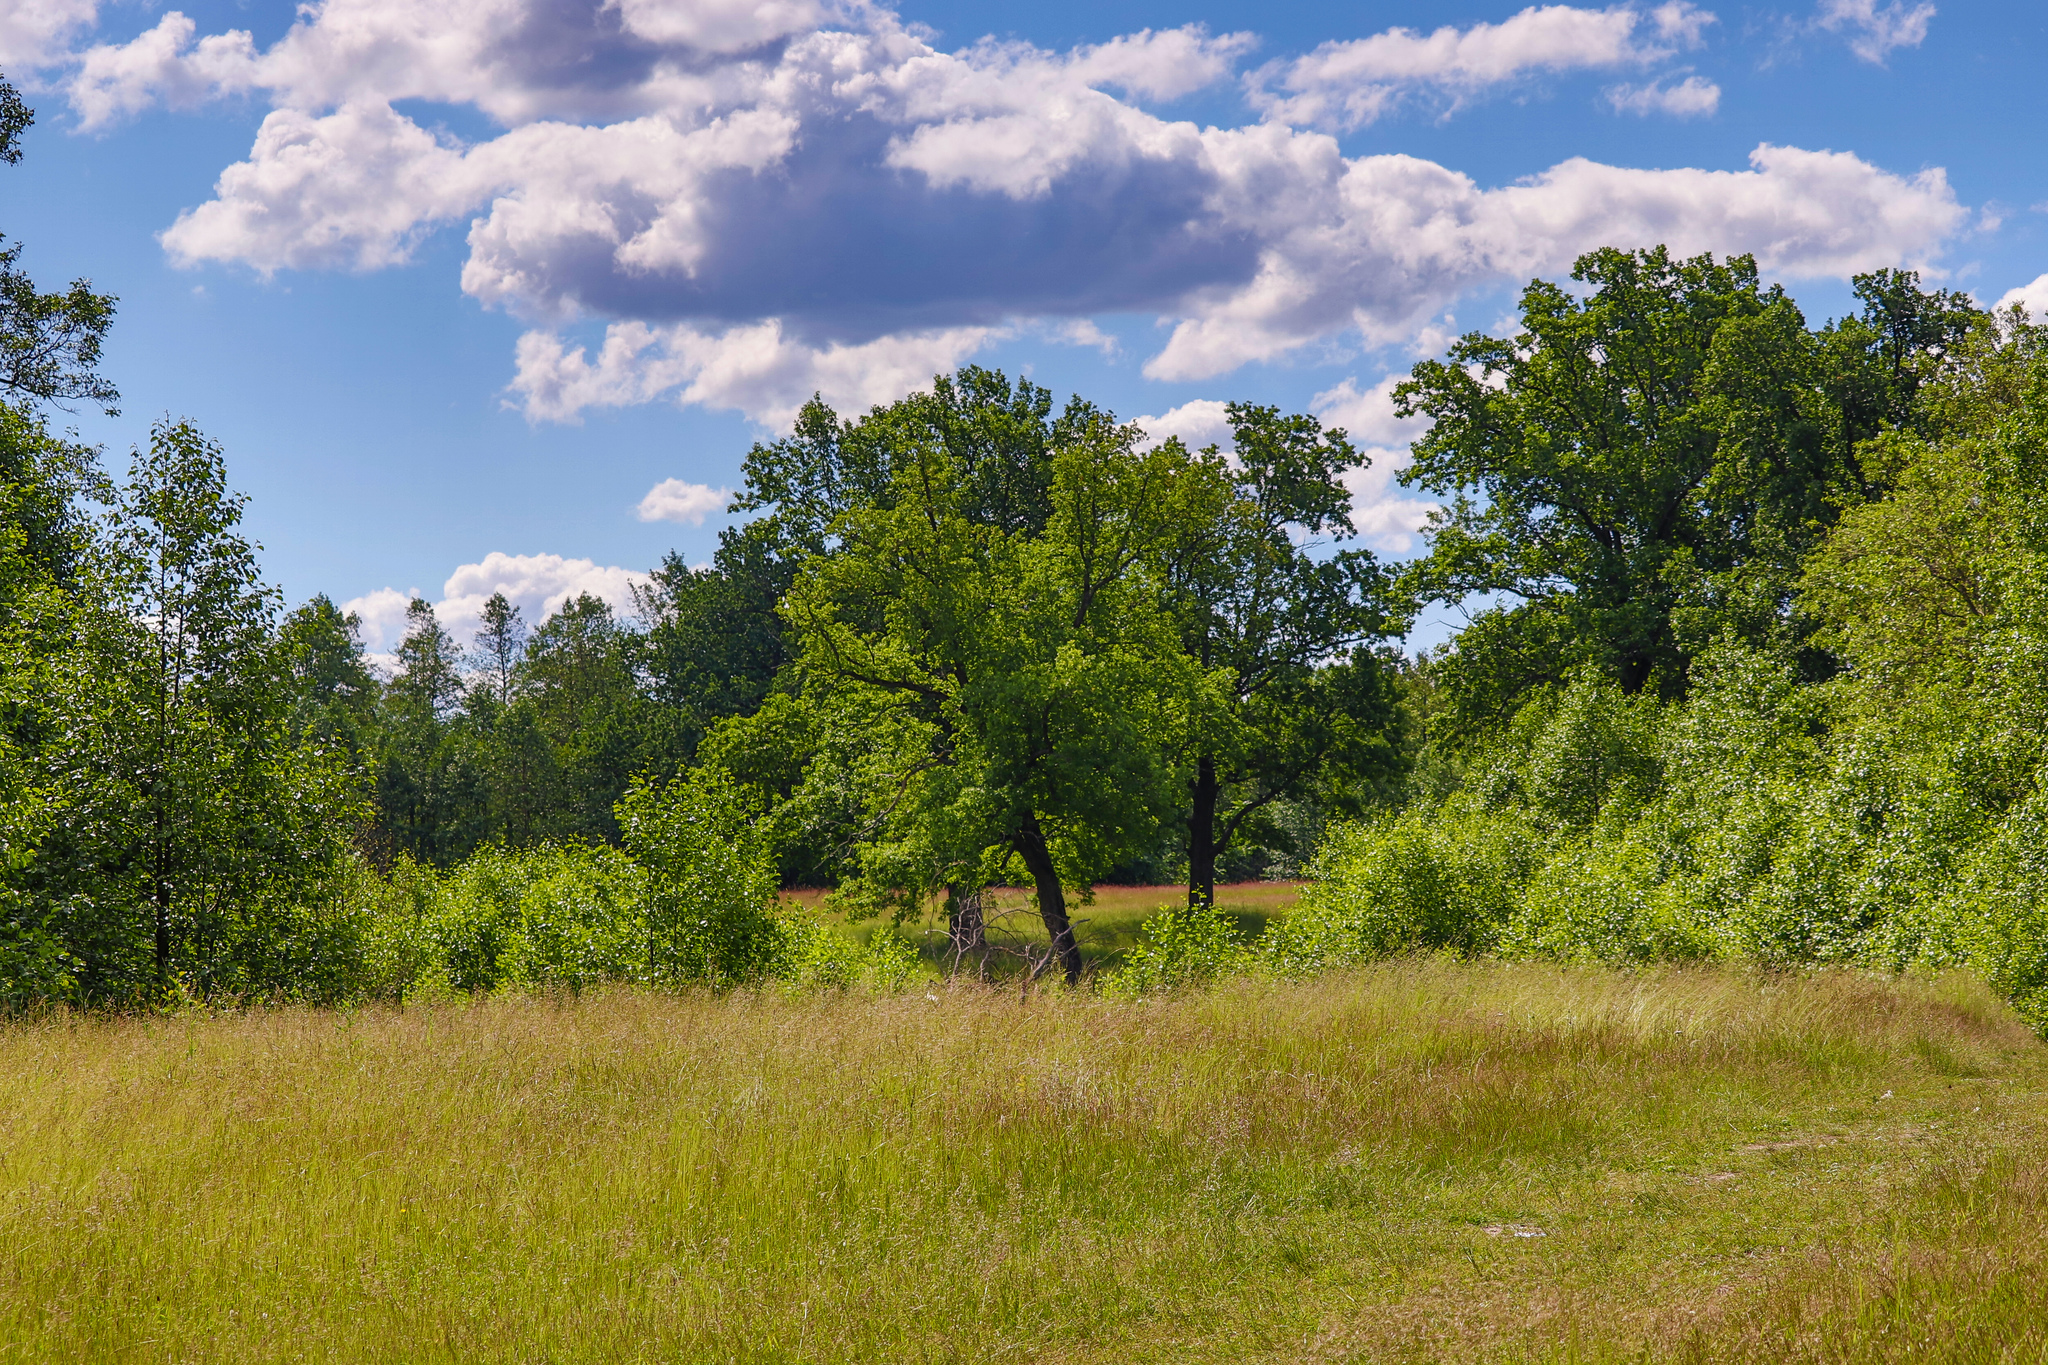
(0, 960), (2048, 1363)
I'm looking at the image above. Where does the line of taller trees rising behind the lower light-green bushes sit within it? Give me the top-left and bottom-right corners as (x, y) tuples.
(0, 66), (2019, 1001)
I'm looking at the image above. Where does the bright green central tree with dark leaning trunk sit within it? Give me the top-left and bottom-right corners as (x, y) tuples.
(782, 411), (1217, 980)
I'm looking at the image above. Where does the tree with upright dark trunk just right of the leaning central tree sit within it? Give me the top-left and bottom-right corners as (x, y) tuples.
(1167, 403), (1397, 905)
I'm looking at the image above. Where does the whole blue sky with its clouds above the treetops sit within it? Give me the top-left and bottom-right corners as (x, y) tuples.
(0, 0), (2048, 653)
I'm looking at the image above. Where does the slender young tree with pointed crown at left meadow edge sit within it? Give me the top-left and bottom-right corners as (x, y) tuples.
(29, 422), (360, 999)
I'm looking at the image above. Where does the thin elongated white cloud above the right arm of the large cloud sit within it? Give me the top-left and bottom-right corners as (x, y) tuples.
(1245, 0), (1714, 129)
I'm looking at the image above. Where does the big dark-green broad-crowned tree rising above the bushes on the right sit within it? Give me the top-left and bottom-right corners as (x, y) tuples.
(1395, 248), (1970, 729)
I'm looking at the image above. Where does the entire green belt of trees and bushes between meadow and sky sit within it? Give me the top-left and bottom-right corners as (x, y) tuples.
(0, 69), (2048, 1019)
